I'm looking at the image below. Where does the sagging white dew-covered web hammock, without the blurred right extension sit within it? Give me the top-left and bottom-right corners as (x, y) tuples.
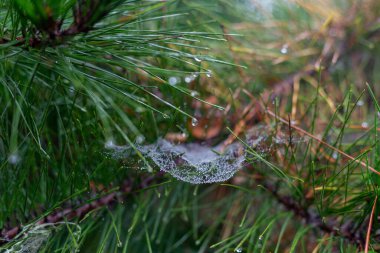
(107, 139), (244, 184)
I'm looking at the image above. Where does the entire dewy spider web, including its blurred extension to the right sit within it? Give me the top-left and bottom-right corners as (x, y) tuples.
(106, 123), (304, 184)
